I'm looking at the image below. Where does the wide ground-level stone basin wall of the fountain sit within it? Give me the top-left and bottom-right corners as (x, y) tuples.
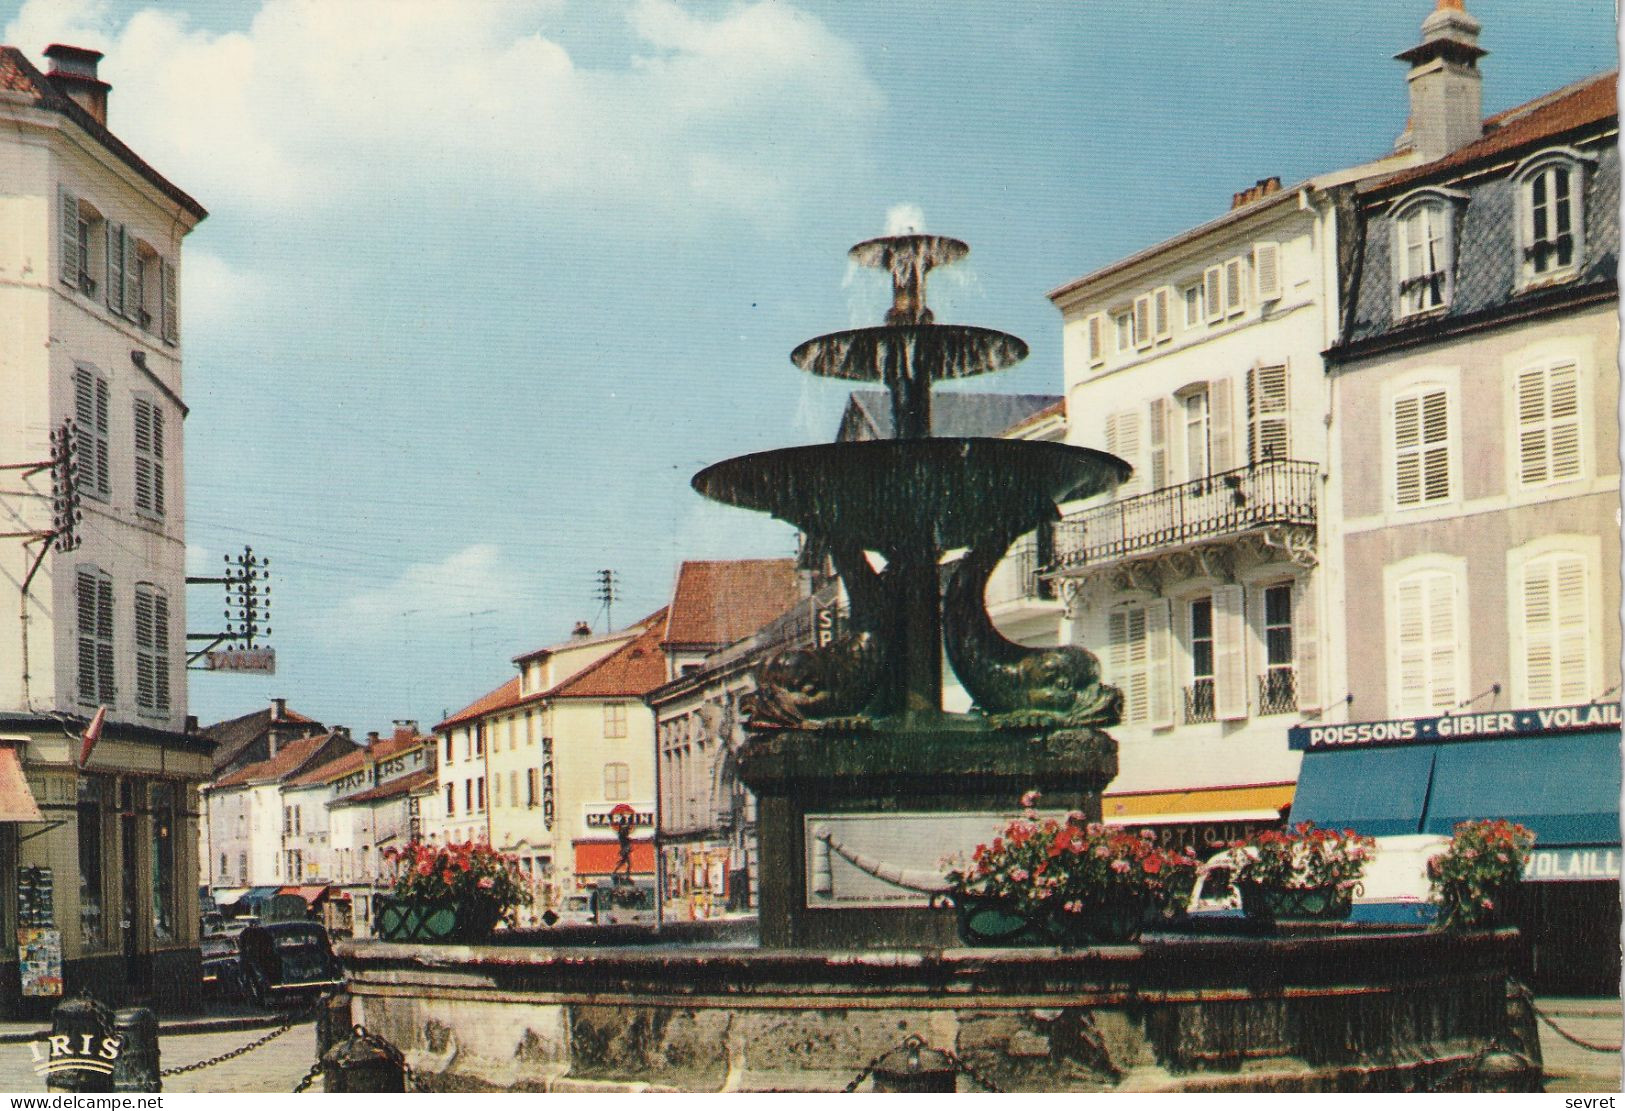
(338, 931), (1541, 1092)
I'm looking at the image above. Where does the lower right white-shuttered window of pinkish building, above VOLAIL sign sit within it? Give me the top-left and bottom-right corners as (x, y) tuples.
(1513, 551), (1593, 707)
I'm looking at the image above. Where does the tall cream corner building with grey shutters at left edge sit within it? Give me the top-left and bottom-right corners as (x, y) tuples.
(0, 45), (211, 1012)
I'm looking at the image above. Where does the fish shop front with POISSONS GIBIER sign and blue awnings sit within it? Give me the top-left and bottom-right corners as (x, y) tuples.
(1289, 703), (1620, 992)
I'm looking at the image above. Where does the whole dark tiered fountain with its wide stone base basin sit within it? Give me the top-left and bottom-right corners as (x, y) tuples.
(340, 236), (1537, 1090)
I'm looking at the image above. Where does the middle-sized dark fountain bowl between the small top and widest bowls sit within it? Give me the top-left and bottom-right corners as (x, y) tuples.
(790, 323), (1027, 382)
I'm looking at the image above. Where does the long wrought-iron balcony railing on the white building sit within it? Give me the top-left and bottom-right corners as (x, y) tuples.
(1051, 460), (1320, 572)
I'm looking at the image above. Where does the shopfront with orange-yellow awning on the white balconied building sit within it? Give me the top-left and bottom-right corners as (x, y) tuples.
(1100, 783), (1294, 858)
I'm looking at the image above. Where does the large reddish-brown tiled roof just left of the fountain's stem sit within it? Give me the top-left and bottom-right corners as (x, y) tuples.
(661, 559), (801, 648)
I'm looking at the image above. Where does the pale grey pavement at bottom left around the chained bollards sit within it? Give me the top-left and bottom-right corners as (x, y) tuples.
(0, 1022), (322, 1093)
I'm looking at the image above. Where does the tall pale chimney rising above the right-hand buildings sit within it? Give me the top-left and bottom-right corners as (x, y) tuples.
(1394, 0), (1489, 162)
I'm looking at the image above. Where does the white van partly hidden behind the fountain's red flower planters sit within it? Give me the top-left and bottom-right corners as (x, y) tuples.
(1186, 833), (1450, 926)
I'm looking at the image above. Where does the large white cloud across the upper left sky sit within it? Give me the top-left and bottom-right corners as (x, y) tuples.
(5, 0), (882, 219)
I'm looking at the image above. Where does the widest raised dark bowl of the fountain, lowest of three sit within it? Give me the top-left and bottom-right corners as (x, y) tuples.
(694, 437), (1131, 552)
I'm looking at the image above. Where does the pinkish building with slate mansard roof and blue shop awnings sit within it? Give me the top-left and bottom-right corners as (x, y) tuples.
(1300, 58), (1620, 992)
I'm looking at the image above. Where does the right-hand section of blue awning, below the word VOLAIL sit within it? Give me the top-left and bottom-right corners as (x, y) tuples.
(1430, 729), (1620, 848)
